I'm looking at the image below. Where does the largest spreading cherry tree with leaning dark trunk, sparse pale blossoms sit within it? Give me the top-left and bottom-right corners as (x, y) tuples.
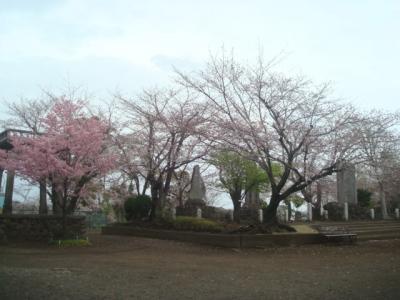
(177, 54), (359, 223)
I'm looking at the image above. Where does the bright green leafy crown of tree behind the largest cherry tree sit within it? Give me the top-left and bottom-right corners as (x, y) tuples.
(211, 151), (281, 197)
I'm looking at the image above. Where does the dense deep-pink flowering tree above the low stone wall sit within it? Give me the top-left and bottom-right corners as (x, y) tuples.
(0, 98), (114, 221)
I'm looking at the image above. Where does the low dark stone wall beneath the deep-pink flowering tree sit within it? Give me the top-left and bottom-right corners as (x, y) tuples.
(0, 215), (86, 241)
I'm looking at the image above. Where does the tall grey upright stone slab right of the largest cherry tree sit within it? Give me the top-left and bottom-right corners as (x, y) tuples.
(336, 164), (357, 204)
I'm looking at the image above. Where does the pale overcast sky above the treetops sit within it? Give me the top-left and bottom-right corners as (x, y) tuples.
(0, 0), (400, 110)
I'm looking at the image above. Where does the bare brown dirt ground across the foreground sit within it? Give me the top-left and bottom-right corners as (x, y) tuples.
(0, 233), (400, 300)
